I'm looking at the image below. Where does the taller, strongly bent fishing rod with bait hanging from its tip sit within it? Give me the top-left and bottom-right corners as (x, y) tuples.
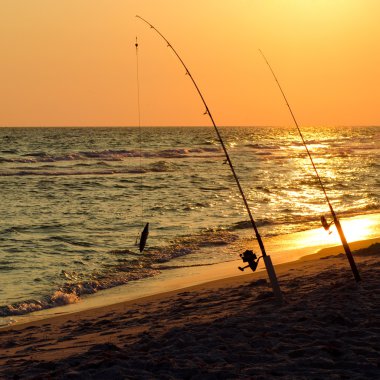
(136, 16), (282, 302)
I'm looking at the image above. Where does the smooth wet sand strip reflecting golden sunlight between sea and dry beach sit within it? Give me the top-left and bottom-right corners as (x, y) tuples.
(0, 213), (380, 330)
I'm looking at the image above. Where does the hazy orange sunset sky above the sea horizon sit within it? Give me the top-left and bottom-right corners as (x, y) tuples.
(0, 0), (380, 126)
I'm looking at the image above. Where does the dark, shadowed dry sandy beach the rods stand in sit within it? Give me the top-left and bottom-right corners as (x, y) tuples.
(0, 238), (380, 379)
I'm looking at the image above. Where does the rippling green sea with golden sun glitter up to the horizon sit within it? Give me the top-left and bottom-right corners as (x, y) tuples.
(0, 127), (380, 317)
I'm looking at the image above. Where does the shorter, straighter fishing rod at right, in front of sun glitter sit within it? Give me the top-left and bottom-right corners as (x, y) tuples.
(259, 49), (361, 282)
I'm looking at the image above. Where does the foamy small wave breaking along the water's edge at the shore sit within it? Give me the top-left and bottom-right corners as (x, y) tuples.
(0, 230), (238, 317)
